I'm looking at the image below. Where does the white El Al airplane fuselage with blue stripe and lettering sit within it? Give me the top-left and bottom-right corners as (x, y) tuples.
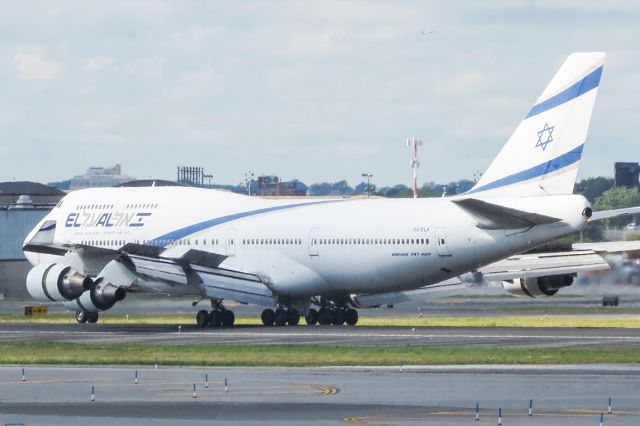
(25, 187), (588, 297)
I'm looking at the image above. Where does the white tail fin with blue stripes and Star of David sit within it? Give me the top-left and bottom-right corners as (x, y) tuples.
(467, 52), (605, 197)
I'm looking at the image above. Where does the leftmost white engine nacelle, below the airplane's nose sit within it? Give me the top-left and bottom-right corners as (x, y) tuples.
(27, 263), (93, 302)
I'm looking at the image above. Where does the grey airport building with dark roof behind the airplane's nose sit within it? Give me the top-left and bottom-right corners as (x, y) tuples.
(0, 182), (65, 299)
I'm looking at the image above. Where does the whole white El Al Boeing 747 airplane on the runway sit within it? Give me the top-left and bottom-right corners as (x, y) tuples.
(23, 53), (638, 326)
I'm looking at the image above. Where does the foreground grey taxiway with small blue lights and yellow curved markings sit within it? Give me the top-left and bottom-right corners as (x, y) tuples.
(0, 365), (640, 425)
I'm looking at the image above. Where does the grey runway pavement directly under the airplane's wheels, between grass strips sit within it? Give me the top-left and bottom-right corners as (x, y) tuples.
(0, 323), (640, 348)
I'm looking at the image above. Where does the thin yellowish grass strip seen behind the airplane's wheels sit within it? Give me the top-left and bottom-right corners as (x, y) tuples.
(5, 313), (640, 328)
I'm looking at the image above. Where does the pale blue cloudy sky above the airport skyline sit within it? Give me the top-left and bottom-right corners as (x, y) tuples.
(0, 0), (640, 185)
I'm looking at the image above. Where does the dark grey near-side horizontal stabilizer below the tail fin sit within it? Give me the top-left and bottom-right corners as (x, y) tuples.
(452, 198), (560, 229)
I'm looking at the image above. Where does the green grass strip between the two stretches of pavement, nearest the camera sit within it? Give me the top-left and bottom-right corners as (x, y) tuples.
(0, 342), (640, 367)
